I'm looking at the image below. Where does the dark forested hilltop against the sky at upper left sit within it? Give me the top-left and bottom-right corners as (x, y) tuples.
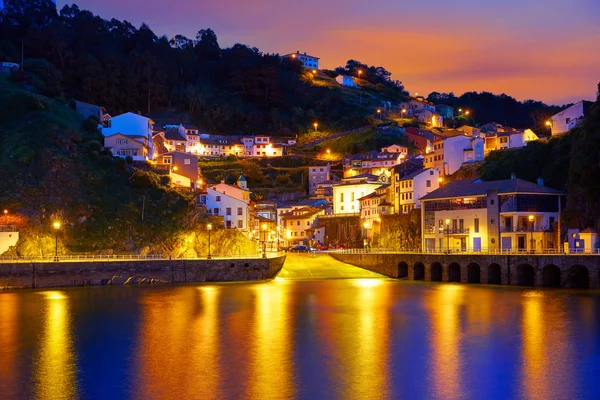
(0, 0), (402, 134)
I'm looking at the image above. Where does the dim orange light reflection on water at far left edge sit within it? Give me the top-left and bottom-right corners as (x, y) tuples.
(0, 293), (18, 398)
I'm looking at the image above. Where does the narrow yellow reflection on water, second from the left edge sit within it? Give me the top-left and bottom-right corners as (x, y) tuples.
(33, 291), (77, 400)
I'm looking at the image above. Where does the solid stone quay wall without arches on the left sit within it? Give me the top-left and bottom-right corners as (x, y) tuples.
(0, 256), (285, 289)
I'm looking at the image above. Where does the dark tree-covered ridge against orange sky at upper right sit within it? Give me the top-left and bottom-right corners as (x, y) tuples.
(427, 92), (564, 130)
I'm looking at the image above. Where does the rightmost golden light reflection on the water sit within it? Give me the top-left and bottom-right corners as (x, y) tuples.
(521, 291), (575, 400)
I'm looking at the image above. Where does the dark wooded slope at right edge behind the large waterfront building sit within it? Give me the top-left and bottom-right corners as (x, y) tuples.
(479, 84), (600, 228)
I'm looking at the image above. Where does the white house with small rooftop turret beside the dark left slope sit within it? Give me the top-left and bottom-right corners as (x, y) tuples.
(205, 176), (250, 230)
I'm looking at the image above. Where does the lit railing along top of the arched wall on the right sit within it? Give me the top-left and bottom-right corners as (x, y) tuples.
(330, 248), (600, 256)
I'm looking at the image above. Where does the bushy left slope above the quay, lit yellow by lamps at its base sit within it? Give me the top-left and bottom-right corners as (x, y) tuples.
(0, 75), (254, 255)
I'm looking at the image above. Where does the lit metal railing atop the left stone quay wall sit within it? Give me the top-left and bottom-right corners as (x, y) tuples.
(0, 251), (285, 263)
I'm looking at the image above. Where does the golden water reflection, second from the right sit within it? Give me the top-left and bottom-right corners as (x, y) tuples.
(429, 284), (465, 399)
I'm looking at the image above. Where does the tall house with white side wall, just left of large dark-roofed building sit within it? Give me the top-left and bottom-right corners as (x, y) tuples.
(395, 168), (440, 214)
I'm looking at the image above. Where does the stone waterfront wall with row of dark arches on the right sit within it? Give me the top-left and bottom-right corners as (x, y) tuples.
(329, 250), (600, 289)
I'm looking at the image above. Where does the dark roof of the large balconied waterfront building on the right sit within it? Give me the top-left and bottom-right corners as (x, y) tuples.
(421, 179), (562, 201)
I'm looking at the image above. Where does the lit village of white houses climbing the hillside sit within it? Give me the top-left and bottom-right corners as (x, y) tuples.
(56, 52), (597, 255)
